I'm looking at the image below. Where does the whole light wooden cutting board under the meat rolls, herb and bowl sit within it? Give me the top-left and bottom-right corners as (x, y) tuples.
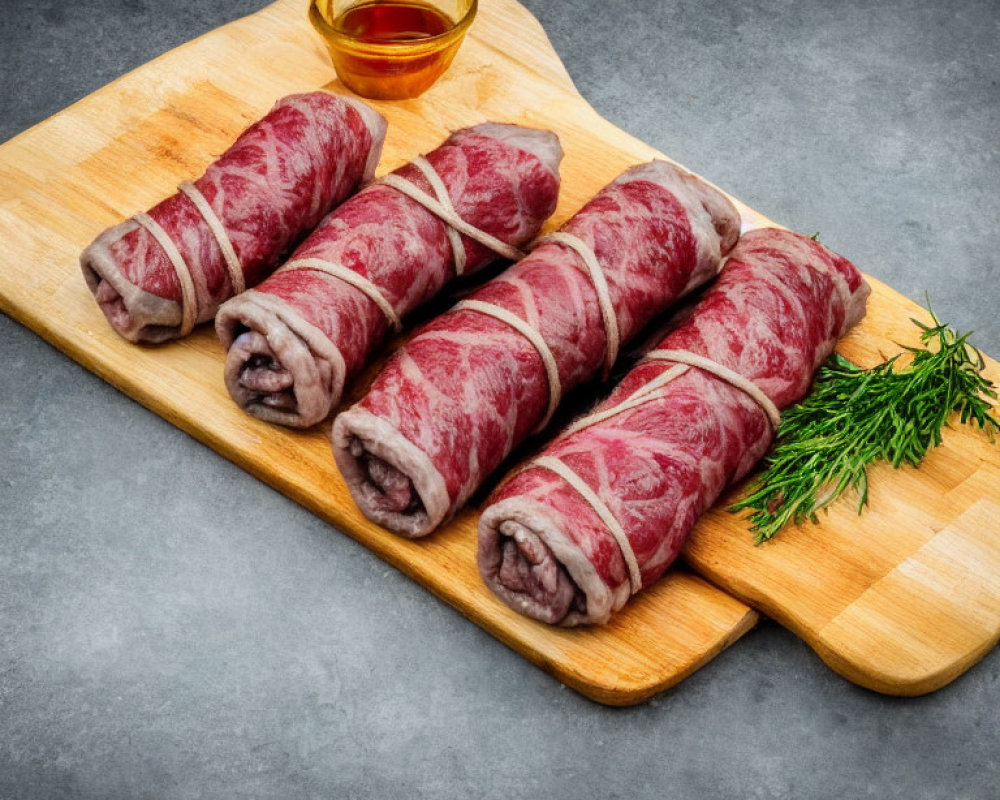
(0, 0), (1000, 705)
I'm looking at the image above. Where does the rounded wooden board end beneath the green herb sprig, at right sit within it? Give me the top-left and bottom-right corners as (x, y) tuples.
(685, 290), (1000, 695)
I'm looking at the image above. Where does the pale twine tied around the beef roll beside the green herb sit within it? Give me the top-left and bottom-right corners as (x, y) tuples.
(524, 350), (781, 594)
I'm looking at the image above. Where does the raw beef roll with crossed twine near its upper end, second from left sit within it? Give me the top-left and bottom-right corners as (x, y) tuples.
(216, 123), (562, 427)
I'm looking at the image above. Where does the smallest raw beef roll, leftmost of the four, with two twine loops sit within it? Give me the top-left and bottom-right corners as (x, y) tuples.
(80, 92), (386, 342)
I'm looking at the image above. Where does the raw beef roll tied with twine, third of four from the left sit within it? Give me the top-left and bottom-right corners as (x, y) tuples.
(333, 161), (739, 537)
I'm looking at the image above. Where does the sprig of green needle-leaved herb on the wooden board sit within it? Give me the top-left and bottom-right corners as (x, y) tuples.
(730, 306), (1000, 544)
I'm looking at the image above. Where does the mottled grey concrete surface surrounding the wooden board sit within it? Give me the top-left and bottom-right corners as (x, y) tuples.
(0, 0), (1000, 800)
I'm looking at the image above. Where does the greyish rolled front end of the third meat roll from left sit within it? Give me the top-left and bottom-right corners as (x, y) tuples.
(332, 406), (450, 538)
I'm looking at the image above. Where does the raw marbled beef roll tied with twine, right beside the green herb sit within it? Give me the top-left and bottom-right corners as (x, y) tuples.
(478, 229), (869, 625)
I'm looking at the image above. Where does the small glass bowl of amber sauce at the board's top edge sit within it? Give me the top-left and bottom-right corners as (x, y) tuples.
(309, 0), (477, 100)
